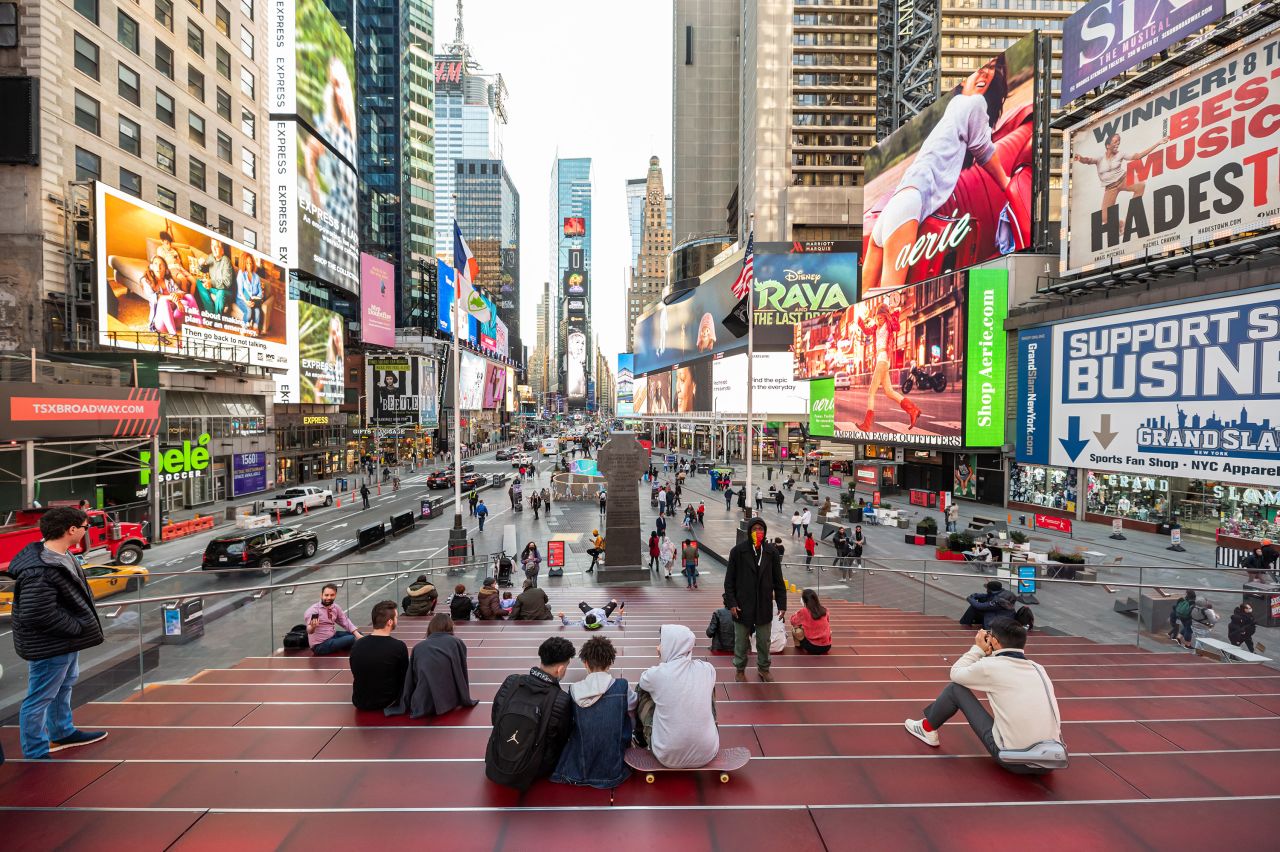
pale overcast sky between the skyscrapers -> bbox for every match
[435,0,672,360]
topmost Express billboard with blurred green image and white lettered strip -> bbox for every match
[268,0,356,164]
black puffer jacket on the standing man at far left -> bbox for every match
[9,541,102,660]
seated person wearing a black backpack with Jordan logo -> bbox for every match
[484,636,573,792]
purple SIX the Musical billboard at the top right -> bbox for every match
[1061,0,1226,106]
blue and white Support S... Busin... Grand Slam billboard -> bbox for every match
[1014,288,1280,487]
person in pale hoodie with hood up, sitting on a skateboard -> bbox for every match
[636,624,719,769]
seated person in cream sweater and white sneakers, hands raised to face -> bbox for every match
[905,618,1065,774]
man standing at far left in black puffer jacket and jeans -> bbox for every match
[9,508,106,760]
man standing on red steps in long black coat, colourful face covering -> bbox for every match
[724,518,787,683]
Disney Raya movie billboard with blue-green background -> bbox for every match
[751,241,858,349]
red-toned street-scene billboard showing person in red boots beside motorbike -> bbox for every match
[794,274,965,446]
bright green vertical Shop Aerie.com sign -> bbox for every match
[964,269,1009,446]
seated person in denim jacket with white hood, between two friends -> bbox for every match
[552,636,636,789]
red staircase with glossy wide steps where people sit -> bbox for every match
[0,588,1280,852]
